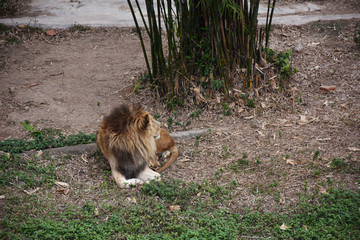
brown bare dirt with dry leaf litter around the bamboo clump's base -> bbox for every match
[0,2,360,211]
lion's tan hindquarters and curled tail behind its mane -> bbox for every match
[153,128,179,173]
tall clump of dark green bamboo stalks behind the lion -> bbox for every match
[128,0,276,101]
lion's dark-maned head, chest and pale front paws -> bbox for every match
[96,104,160,188]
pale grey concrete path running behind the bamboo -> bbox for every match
[0,0,360,28]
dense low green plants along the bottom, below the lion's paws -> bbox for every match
[0,177,360,239]
